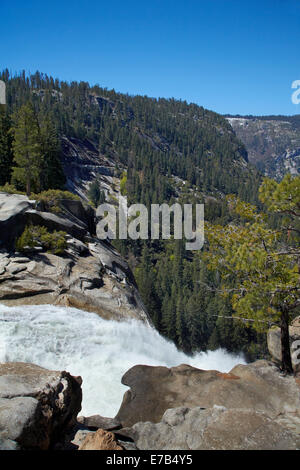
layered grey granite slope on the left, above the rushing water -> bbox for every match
[0,193,149,322]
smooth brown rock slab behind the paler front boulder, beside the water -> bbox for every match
[116,361,300,430]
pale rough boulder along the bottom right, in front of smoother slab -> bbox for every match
[119,406,300,450]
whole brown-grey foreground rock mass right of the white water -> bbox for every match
[116,361,300,450]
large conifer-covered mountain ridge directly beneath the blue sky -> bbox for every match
[0,70,259,204]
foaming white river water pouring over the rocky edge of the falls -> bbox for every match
[0,305,245,417]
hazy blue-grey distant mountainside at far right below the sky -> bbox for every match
[227,115,300,179]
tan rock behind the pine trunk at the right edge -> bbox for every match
[267,317,300,372]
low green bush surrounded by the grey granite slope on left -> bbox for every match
[16,225,67,255]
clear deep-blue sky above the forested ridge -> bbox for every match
[0,0,300,115]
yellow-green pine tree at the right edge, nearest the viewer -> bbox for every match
[206,175,300,372]
